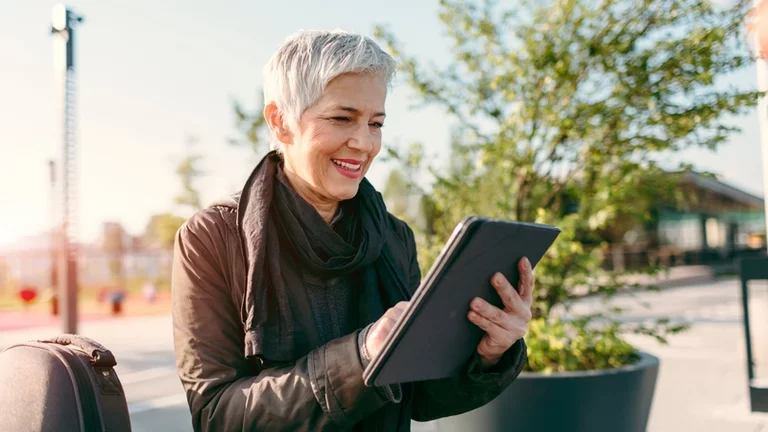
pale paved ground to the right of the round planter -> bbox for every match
[577,279,768,432]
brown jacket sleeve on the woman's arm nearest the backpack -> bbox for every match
[172,214,387,431]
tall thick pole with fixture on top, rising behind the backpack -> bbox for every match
[51,4,83,334]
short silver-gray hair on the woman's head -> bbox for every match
[264,29,397,150]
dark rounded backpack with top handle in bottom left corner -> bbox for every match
[0,334,131,432]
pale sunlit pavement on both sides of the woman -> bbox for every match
[0,280,768,432]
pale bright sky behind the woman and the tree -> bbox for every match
[0,0,763,246]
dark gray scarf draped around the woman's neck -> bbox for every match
[237,152,409,362]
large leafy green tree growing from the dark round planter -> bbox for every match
[376,0,758,370]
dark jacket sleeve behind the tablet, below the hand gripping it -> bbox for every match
[406,223,528,421]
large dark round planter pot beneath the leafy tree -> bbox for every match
[437,352,659,432]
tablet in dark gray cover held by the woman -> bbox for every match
[363,217,560,386]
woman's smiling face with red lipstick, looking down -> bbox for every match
[283,74,387,202]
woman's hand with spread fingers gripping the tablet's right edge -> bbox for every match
[467,258,533,368]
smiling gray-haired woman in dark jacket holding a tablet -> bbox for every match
[173,31,533,431]
